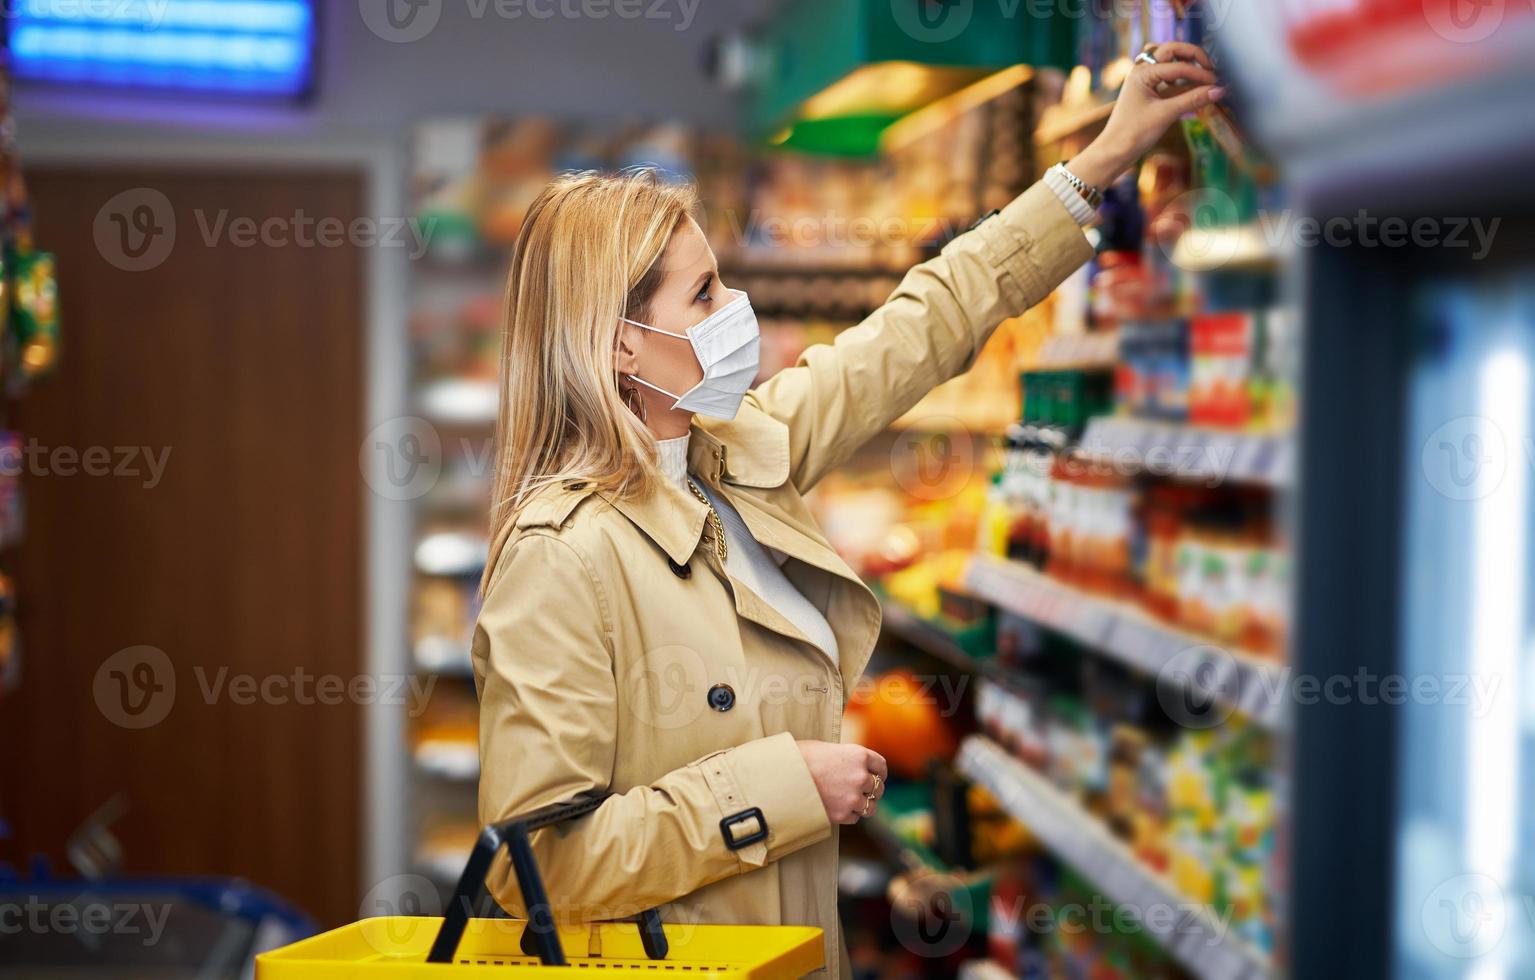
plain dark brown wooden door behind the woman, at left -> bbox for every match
[0,167,373,925]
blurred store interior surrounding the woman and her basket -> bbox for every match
[0,0,1535,980]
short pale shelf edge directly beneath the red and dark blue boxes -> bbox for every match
[1081,416,1294,487]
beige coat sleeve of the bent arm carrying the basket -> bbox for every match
[474,533,830,920]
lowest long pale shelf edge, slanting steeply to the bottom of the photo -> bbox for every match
[958,736,1271,980]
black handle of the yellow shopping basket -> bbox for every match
[427,793,666,966]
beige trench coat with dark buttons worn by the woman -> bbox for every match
[473,184,1091,977]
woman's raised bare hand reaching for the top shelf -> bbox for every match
[1065,41,1226,187]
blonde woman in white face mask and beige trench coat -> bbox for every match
[473,43,1222,977]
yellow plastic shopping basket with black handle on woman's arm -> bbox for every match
[256,796,824,980]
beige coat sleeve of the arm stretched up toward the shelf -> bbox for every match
[749,183,1093,492]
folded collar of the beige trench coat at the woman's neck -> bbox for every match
[603,402,789,565]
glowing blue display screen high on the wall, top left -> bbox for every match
[8,0,315,97]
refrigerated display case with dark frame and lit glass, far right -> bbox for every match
[1226,0,1535,978]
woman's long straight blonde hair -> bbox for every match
[480,169,697,588]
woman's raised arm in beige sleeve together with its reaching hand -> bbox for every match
[751,41,1225,490]
